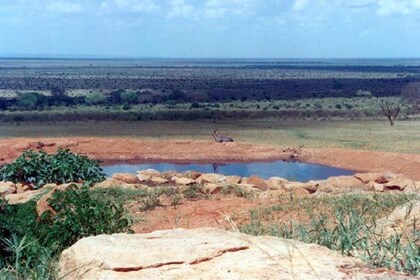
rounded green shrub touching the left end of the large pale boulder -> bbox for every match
[41,185,130,248]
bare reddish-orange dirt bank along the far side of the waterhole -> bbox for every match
[0,137,420,180]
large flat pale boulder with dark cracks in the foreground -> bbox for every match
[58,228,408,280]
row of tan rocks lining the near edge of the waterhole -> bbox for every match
[0,169,420,204]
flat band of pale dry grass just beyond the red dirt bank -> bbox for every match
[0,119,420,154]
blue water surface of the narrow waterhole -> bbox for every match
[103,161,354,182]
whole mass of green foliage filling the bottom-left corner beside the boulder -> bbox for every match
[0,185,131,279]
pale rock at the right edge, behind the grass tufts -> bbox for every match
[375,200,420,238]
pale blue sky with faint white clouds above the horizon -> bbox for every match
[0,0,420,58]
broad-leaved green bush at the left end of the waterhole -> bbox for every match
[0,149,105,188]
